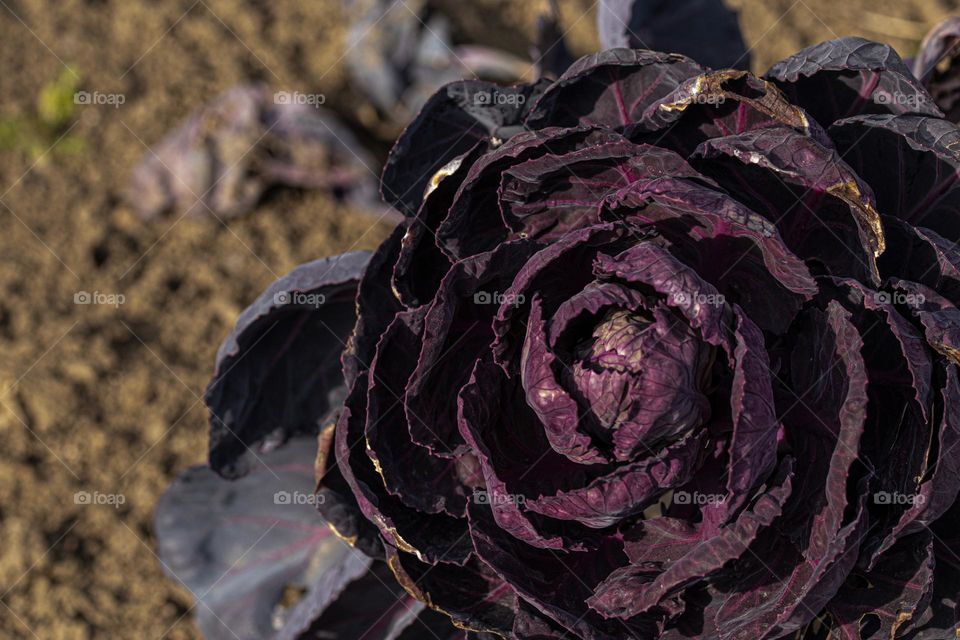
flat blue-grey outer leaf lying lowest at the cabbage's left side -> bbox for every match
[155,437,371,640]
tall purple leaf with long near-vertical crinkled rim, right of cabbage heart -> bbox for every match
[717,301,869,640]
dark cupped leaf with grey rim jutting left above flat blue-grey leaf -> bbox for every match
[204,251,370,478]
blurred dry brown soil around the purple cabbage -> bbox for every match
[0,0,958,640]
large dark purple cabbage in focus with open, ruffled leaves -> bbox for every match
[159,12,960,640]
